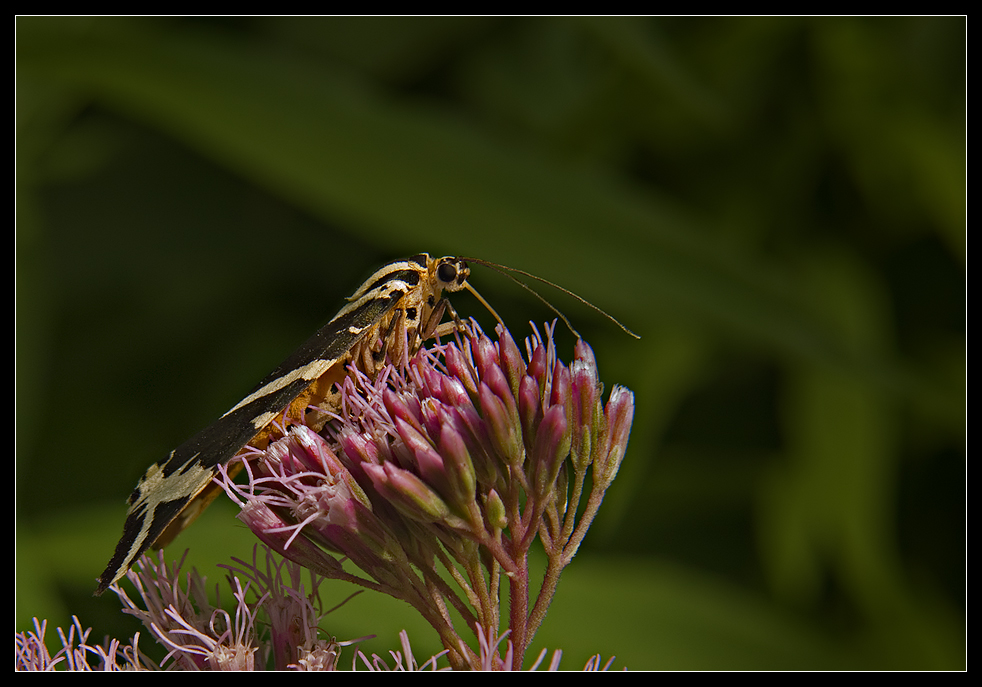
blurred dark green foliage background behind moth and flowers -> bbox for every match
[15,17,966,669]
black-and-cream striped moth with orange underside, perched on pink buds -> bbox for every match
[96,253,470,595]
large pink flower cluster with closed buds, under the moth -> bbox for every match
[224,325,634,668]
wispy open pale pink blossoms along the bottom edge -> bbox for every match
[14,547,624,671]
